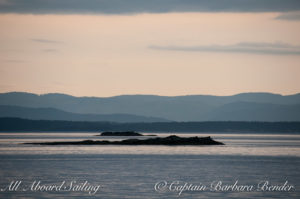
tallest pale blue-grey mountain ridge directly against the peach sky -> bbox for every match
[0,92,300,121]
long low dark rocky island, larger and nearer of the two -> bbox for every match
[24,135,224,146]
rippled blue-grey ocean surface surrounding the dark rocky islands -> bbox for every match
[0,132,300,199]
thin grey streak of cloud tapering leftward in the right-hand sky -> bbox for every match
[148,42,300,55]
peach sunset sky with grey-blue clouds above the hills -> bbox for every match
[0,0,300,97]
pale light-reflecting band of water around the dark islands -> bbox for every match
[0,133,300,157]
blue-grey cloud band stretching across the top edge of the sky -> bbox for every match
[0,0,300,14]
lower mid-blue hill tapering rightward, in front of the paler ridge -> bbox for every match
[0,105,169,123]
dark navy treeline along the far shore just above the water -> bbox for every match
[0,118,300,133]
